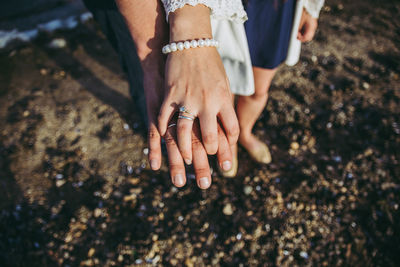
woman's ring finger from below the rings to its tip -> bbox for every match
[177,115,193,165]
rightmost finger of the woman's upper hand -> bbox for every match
[218,106,240,145]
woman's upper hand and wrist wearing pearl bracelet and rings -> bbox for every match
[158,5,239,164]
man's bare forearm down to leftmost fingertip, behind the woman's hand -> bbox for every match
[116,0,168,170]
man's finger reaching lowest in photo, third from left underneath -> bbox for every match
[192,122,211,189]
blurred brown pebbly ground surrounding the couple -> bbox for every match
[0,0,400,266]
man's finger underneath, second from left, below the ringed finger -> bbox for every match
[164,126,186,187]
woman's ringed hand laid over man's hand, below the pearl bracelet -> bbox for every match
[146,47,239,189]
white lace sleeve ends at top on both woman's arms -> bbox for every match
[161,0,324,22]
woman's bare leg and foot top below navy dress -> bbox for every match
[236,67,276,163]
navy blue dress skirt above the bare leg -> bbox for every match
[245,0,296,69]
